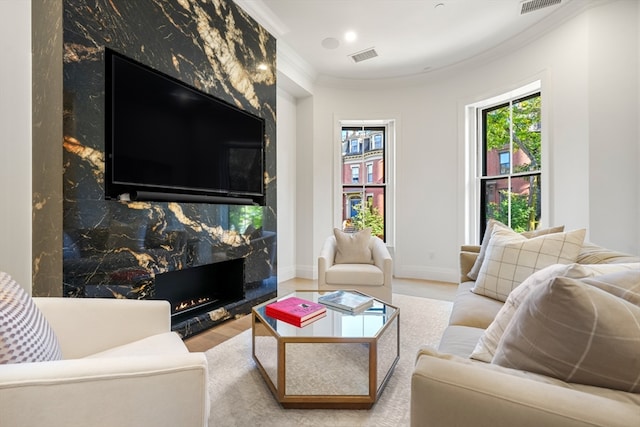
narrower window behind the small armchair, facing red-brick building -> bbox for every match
[341,126,387,239]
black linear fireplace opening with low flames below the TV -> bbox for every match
[155,258,245,325]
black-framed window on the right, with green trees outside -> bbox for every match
[477,92,542,236]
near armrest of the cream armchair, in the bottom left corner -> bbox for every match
[0,353,209,427]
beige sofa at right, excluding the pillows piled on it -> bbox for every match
[411,234,640,427]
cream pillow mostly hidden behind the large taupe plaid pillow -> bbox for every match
[470,263,640,363]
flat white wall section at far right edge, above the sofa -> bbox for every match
[588,1,640,252]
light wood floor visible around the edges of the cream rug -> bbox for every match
[185,278,457,351]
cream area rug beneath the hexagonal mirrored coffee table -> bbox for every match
[206,294,451,427]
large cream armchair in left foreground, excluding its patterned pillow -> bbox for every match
[0,298,209,427]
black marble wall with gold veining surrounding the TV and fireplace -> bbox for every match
[62,0,276,336]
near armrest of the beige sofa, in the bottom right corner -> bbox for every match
[411,354,640,427]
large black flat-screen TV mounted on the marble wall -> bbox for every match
[105,49,265,204]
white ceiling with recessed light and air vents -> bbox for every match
[235,0,602,80]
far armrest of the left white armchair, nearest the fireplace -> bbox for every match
[33,297,171,359]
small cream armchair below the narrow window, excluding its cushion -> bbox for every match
[318,236,393,303]
